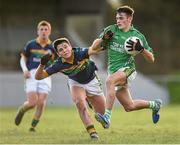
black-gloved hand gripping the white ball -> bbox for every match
[126,39,144,53]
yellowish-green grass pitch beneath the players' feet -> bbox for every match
[0,105,180,144]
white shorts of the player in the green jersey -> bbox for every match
[115,67,137,91]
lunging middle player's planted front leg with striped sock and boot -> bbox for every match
[71,86,98,139]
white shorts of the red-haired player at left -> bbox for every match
[25,69,51,94]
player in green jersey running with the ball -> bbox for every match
[95,6,161,128]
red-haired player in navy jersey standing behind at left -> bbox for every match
[15,21,54,131]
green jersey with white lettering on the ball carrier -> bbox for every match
[99,24,153,74]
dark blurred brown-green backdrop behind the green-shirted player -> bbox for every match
[106,0,180,74]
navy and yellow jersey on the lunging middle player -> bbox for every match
[46,48,97,84]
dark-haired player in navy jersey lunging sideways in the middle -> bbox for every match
[35,38,105,139]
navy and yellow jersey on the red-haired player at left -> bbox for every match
[22,38,54,70]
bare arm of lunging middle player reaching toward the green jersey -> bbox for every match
[88,39,103,55]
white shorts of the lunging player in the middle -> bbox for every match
[68,76,104,97]
